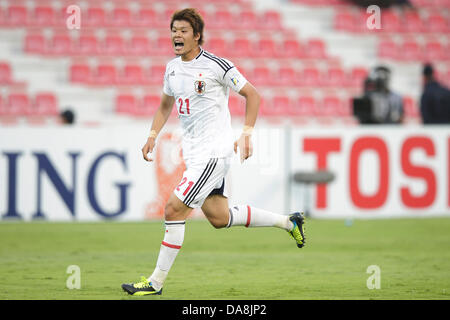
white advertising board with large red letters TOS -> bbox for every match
[290,126,450,217]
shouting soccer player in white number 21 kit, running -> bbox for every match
[122,8,305,296]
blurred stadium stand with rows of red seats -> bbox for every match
[0,0,450,121]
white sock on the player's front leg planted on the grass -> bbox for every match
[148,221,185,290]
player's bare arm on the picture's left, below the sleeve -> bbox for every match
[142,93,175,161]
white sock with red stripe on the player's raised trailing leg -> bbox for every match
[227,205,294,231]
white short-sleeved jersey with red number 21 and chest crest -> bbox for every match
[163,48,247,162]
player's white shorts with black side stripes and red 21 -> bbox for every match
[174,158,231,208]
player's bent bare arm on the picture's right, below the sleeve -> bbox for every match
[234,82,261,163]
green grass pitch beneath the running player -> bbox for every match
[0,218,450,300]
